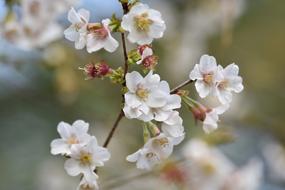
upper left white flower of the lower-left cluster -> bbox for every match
[51,120,91,155]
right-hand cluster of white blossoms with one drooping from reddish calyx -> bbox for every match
[189,55,244,133]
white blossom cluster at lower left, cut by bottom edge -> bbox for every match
[51,120,110,190]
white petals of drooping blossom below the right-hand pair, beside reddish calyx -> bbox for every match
[203,104,229,133]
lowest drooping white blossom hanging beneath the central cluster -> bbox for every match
[127,133,177,170]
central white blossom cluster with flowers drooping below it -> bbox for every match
[123,71,184,169]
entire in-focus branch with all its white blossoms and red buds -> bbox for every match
[48,0,243,190]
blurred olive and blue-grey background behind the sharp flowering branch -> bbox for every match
[0,0,285,190]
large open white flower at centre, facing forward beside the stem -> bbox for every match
[123,71,167,121]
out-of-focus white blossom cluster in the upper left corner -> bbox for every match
[0,0,77,50]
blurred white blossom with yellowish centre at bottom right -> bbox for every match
[184,139,235,190]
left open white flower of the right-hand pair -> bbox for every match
[189,55,220,98]
